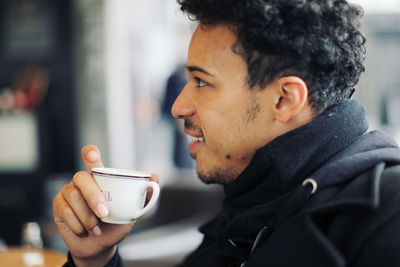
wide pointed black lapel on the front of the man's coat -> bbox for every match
[248,163,385,267]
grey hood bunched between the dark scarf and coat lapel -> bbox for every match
[310,131,400,213]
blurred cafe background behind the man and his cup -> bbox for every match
[0,0,400,266]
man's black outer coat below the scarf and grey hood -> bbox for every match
[180,147,400,267]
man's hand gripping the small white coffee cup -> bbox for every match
[53,145,158,267]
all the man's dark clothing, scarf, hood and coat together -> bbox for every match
[65,100,400,267]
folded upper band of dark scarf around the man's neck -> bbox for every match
[223,100,368,217]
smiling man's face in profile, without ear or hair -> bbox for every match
[172,25,282,184]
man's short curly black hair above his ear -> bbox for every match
[177,0,365,114]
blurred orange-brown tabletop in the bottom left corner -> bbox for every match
[0,247,67,267]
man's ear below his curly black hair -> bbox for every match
[274,76,308,123]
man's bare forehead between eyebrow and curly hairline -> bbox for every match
[188,24,247,73]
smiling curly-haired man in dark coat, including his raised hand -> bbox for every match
[54,0,400,267]
